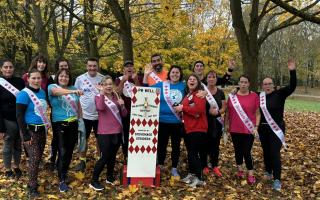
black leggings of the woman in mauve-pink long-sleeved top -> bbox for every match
[92,133,122,181]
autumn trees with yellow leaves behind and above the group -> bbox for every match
[0,0,320,88]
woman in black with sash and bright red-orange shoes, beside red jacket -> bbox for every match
[201,71,227,177]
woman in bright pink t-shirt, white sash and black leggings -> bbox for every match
[225,75,260,184]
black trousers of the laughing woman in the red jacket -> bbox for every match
[185,132,206,180]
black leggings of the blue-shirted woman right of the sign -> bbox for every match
[157,122,182,168]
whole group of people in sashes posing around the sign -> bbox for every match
[0,54,296,196]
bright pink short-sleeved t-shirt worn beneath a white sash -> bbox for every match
[227,92,259,134]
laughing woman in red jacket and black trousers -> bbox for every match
[175,74,208,187]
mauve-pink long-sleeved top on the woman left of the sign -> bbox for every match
[95,95,127,134]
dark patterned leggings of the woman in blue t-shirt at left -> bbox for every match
[25,130,46,188]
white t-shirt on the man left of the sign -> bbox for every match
[74,72,104,120]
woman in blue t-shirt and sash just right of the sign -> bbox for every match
[152,65,185,177]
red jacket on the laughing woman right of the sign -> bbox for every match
[182,91,208,133]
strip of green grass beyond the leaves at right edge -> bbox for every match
[285,99,320,112]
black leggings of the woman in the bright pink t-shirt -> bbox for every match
[231,133,254,170]
